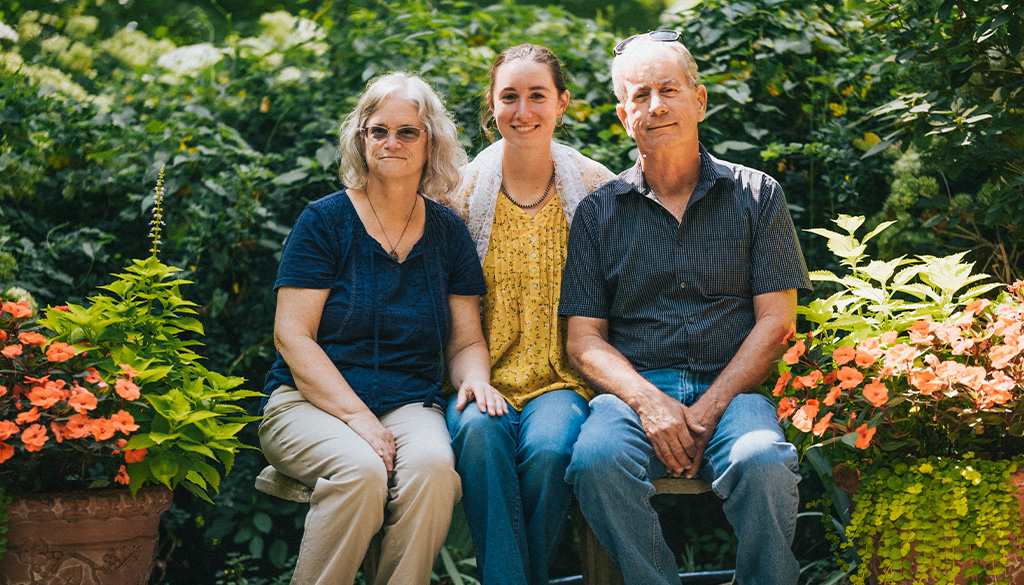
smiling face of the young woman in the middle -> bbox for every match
[490,58,569,148]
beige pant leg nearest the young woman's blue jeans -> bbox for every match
[376,403,462,585]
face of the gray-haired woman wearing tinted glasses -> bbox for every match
[364,97,428,181]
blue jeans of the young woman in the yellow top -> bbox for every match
[447,390,589,585]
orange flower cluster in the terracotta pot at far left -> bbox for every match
[0,301,146,485]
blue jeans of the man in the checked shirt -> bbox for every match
[565,369,800,585]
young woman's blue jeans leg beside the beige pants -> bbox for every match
[447,401,529,585]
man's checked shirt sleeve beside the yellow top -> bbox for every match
[558,201,611,319]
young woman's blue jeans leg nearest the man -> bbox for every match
[517,390,590,585]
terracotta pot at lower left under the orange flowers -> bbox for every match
[0,488,174,585]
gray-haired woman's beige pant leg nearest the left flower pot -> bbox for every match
[259,386,387,585]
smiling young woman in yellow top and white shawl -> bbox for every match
[447,44,612,585]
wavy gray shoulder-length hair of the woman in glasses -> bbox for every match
[338,72,468,201]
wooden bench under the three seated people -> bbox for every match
[256,465,711,585]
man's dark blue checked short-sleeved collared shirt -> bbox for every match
[558,145,811,373]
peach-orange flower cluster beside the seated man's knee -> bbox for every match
[772,290,1024,449]
